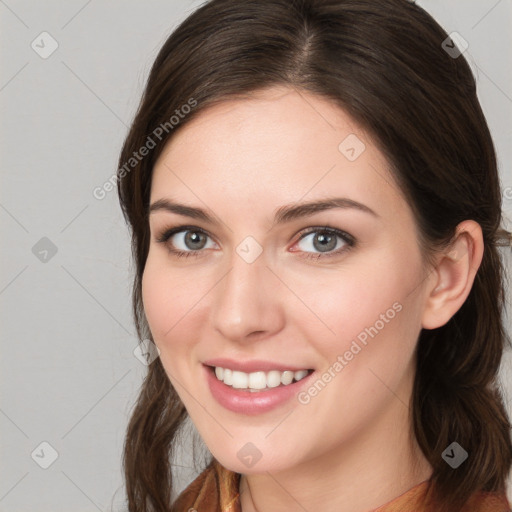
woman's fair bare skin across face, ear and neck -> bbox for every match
[142,87,483,512]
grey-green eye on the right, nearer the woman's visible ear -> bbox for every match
[296,226,355,259]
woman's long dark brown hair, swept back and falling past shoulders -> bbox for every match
[117,0,512,512]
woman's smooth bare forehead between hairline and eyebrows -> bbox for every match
[151,87,407,222]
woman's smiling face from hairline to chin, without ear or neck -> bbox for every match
[142,88,429,473]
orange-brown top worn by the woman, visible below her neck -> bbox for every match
[172,458,511,512]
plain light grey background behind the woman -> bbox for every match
[0,0,512,512]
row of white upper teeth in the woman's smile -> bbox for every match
[215,366,309,392]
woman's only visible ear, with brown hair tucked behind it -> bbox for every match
[422,220,484,329]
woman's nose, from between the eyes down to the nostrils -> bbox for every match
[212,248,285,343]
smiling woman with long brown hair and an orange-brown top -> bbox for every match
[118,0,512,512]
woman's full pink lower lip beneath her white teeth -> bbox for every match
[203,365,315,416]
